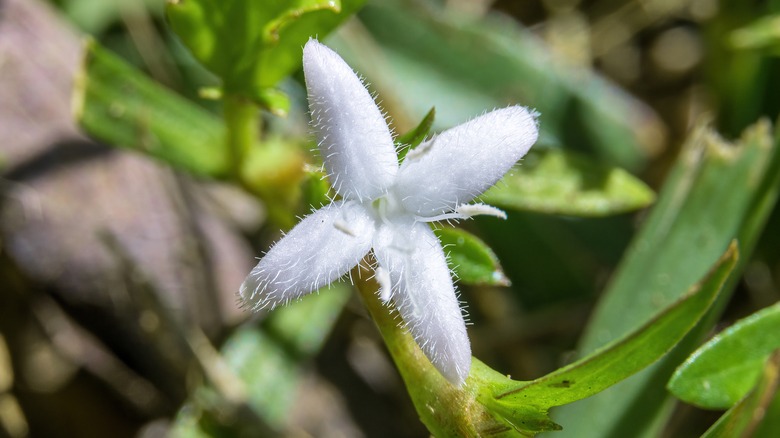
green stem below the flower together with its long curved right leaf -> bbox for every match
[353,244,737,437]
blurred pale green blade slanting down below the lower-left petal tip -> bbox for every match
[172,285,351,437]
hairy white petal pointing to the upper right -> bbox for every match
[396,106,539,216]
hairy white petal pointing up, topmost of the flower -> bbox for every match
[303,40,398,199]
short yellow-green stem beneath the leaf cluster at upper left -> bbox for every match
[223,95,260,181]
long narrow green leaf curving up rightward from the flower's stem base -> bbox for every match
[482,243,738,432]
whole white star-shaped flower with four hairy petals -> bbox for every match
[240,40,538,386]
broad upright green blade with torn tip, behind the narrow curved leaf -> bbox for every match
[555,121,780,438]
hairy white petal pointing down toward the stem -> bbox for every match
[374,221,471,386]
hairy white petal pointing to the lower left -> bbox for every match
[239,201,374,310]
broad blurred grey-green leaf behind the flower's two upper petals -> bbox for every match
[331,2,656,173]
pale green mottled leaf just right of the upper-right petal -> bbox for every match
[481,149,655,216]
